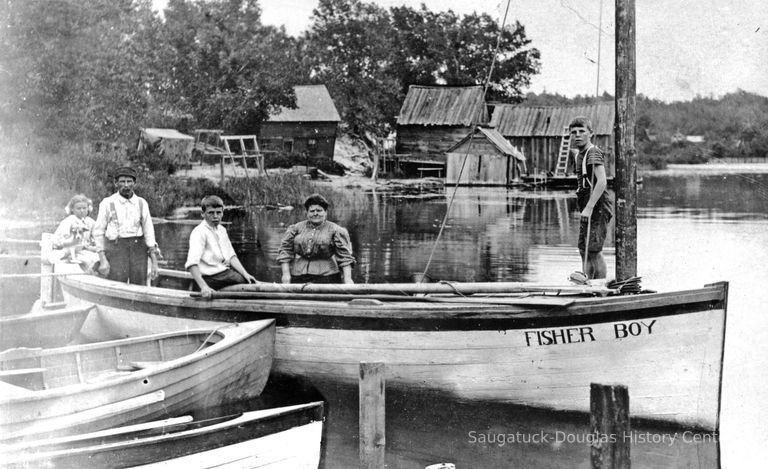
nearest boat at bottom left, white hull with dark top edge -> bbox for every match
[0,402,323,469]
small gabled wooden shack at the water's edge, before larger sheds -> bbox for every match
[445,127,525,186]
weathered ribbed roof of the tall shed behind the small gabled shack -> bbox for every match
[397,85,488,126]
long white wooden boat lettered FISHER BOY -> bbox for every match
[61,264,728,429]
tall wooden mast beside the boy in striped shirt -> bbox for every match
[614,0,637,280]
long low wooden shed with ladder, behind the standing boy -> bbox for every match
[491,102,615,177]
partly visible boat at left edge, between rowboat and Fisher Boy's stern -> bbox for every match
[0,306,92,350]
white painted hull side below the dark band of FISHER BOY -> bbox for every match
[274,310,724,428]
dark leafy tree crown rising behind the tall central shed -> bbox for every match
[303,0,540,135]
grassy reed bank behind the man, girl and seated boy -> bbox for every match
[0,138,343,219]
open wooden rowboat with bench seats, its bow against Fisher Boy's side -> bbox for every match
[0,320,275,440]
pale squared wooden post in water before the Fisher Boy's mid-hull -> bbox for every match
[359,362,386,469]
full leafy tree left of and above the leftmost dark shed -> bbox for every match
[163,0,307,133]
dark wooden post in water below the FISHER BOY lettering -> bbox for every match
[589,383,631,469]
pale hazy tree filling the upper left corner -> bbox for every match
[0,0,166,140]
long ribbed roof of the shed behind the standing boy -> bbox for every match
[491,101,616,137]
